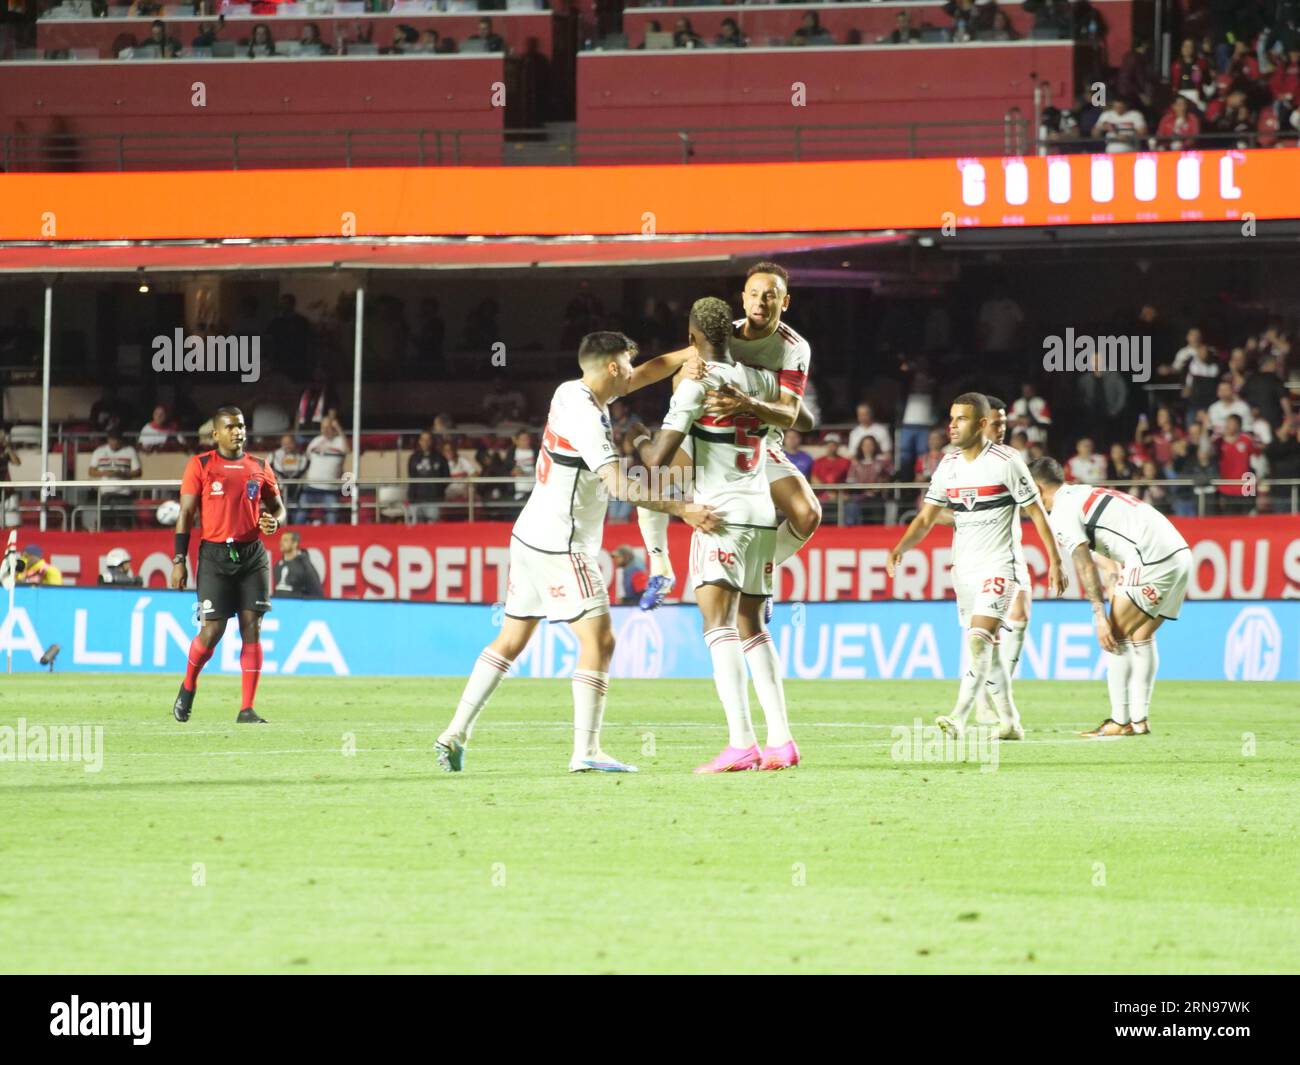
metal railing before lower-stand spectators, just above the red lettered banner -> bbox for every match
[0,475,1300,532]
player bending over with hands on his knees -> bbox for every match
[1030,458,1192,737]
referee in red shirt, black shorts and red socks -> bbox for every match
[172,407,286,724]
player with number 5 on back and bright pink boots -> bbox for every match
[628,296,800,772]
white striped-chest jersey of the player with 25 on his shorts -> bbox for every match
[926,442,1039,576]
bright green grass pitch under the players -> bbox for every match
[0,675,1300,973]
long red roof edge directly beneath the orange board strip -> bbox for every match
[0,234,905,274]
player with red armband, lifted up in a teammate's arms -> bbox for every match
[638,263,822,610]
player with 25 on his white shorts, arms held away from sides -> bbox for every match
[885,391,1066,740]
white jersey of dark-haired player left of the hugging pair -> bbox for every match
[514,381,618,555]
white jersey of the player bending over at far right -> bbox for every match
[1048,485,1187,567]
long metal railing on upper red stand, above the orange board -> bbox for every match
[0,112,1034,172]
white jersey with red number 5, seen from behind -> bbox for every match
[663,363,779,528]
